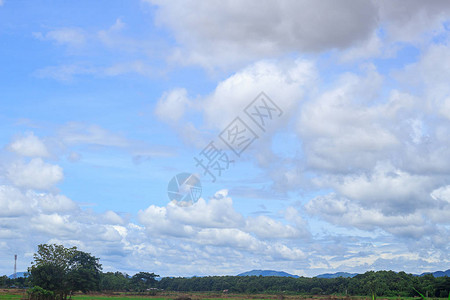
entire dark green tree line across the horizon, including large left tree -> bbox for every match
[0,244,450,300]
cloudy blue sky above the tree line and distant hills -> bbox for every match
[0,0,450,276]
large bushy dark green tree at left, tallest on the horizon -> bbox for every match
[28,244,101,299]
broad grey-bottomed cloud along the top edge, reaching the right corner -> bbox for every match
[146,0,450,67]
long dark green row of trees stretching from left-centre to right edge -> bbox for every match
[158,271,450,297]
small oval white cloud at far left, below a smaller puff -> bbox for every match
[6,158,64,189]
